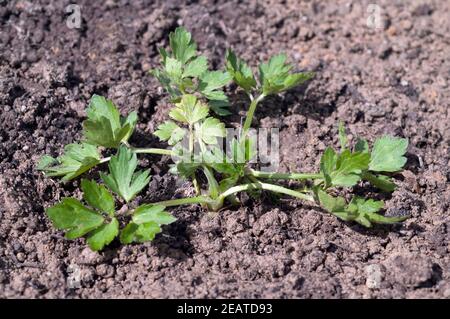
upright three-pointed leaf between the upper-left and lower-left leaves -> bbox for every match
[100,146,150,202]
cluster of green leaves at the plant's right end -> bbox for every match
[314,124,408,227]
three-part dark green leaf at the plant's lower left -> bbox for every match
[47,179,176,251]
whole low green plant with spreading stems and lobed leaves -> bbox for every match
[38,27,408,250]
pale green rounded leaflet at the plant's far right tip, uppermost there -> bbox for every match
[369,135,408,172]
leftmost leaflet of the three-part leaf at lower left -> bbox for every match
[46,198,104,239]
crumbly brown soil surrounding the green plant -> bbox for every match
[0,0,450,298]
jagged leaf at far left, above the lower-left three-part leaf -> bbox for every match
[37,143,100,181]
